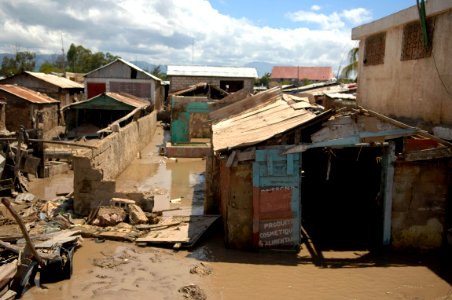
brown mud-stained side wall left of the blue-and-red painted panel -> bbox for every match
[220,159,253,249]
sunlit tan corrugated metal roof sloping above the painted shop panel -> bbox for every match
[212,91,316,151]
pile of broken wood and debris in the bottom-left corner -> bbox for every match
[0,194,81,299]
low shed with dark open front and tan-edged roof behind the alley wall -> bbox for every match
[62,92,150,138]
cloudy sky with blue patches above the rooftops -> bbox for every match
[0,0,416,69]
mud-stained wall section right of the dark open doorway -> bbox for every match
[391,160,450,250]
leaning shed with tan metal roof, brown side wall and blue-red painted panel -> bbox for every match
[205,88,322,248]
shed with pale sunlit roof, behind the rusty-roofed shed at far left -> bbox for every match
[0,71,83,106]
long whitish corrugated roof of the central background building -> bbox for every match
[166,66,258,78]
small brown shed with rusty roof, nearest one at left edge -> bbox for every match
[0,84,60,133]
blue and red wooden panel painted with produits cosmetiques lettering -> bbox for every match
[253,148,301,248]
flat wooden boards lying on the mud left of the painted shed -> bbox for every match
[136,215,220,247]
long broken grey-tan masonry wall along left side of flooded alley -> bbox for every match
[73,111,157,215]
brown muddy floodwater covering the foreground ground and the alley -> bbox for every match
[23,123,452,300]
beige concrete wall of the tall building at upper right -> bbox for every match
[354,7,452,129]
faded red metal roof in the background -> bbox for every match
[271,66,334,80]
